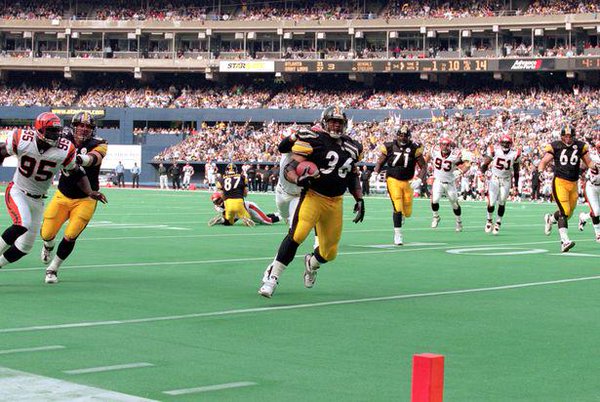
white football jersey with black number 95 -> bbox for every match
[6,129,77,195]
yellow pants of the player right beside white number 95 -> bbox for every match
[41,190,97,241]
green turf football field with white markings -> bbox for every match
[0,189,600,401]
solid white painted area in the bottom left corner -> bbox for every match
[0,367,152,402]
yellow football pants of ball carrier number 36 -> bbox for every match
[290,190,343,261]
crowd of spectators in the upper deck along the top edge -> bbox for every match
[0,0,600,21]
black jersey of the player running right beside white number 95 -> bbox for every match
[58,132,108,198]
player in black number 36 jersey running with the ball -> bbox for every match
[258,106,365,297]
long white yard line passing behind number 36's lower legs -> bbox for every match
[3,239,584,273]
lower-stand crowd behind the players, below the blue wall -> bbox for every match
[155,108,600,199]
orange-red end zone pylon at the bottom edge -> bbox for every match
[411,353,444,402]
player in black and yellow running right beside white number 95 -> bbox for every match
[41,112,108,283]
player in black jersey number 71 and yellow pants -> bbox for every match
[373,126,427,246]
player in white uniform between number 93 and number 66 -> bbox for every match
[481,135,521,235]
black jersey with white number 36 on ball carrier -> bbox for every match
[292,127,362,197]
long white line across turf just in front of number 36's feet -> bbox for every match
[0,275,600,334]
